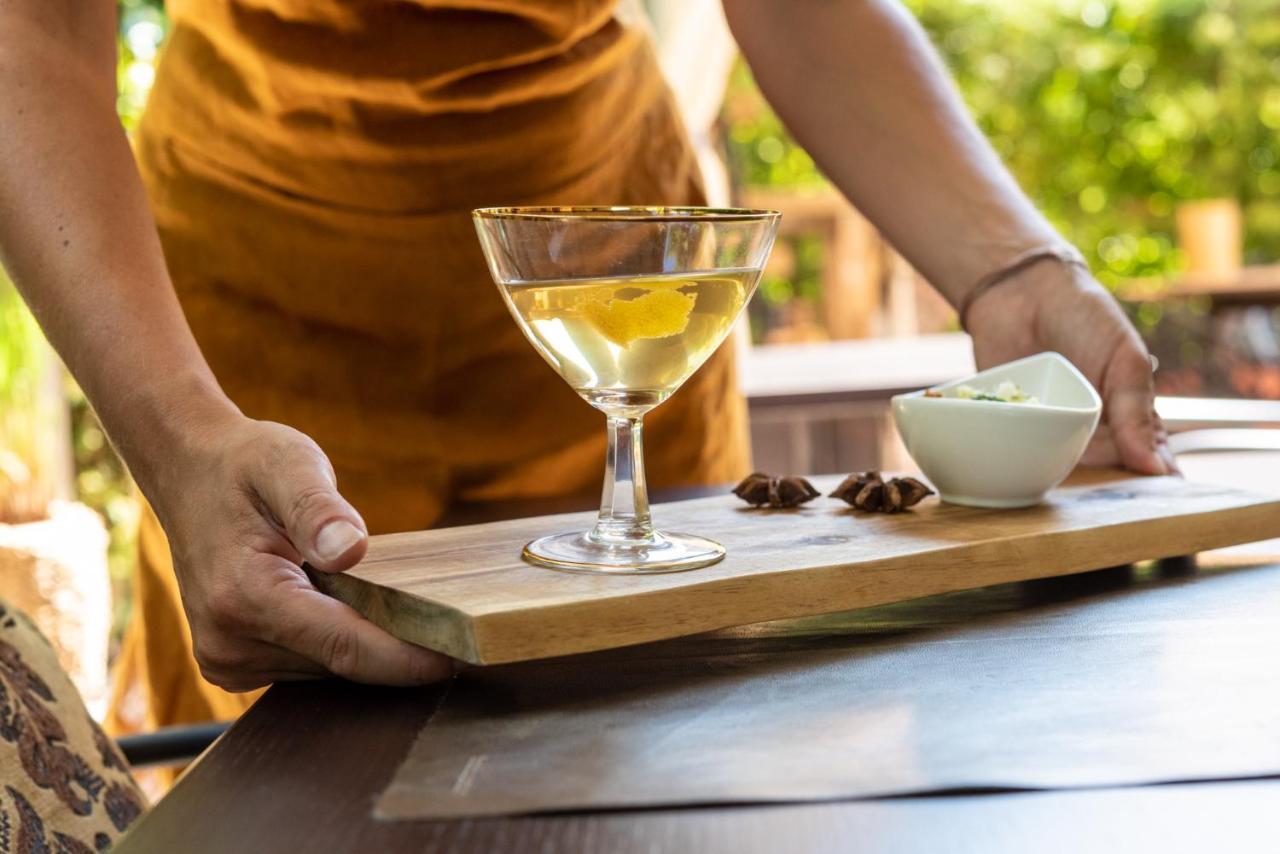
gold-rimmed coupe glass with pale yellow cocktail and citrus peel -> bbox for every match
[474,207,780,574]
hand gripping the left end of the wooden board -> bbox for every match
[146,414,453,691]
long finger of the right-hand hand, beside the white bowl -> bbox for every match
[1103,342,1170,475]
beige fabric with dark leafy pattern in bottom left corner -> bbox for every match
[0,600,146,854]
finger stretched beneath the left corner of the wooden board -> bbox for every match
[269,573,454,685]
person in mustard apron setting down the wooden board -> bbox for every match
[0,0,1172,727]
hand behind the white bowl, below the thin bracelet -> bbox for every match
[969,260,1178,475]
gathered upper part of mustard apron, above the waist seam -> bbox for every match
[141,0,662,213]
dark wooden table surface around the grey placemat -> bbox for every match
[115,455,1280,854]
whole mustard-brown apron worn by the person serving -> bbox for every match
[109,0,749,734]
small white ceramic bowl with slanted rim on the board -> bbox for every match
[893,353,1102,507]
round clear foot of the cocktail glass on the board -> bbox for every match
[524,533,724,575]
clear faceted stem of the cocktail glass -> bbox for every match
[589,415,653,545]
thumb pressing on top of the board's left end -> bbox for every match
[253,437,369,572]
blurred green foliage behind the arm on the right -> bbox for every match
[726,0,1280,284]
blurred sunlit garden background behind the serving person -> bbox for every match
[0,0,1280,706]
